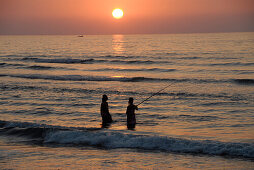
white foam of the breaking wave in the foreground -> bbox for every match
[45,131,254,158]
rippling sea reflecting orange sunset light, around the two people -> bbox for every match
[0,32,254,170]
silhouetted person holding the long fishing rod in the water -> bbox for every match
[126,97,138,129]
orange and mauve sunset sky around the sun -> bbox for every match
[0,0,254,35]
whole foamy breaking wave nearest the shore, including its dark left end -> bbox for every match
[0,121,254,158]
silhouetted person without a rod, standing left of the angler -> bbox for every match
[101,94,112,126]
